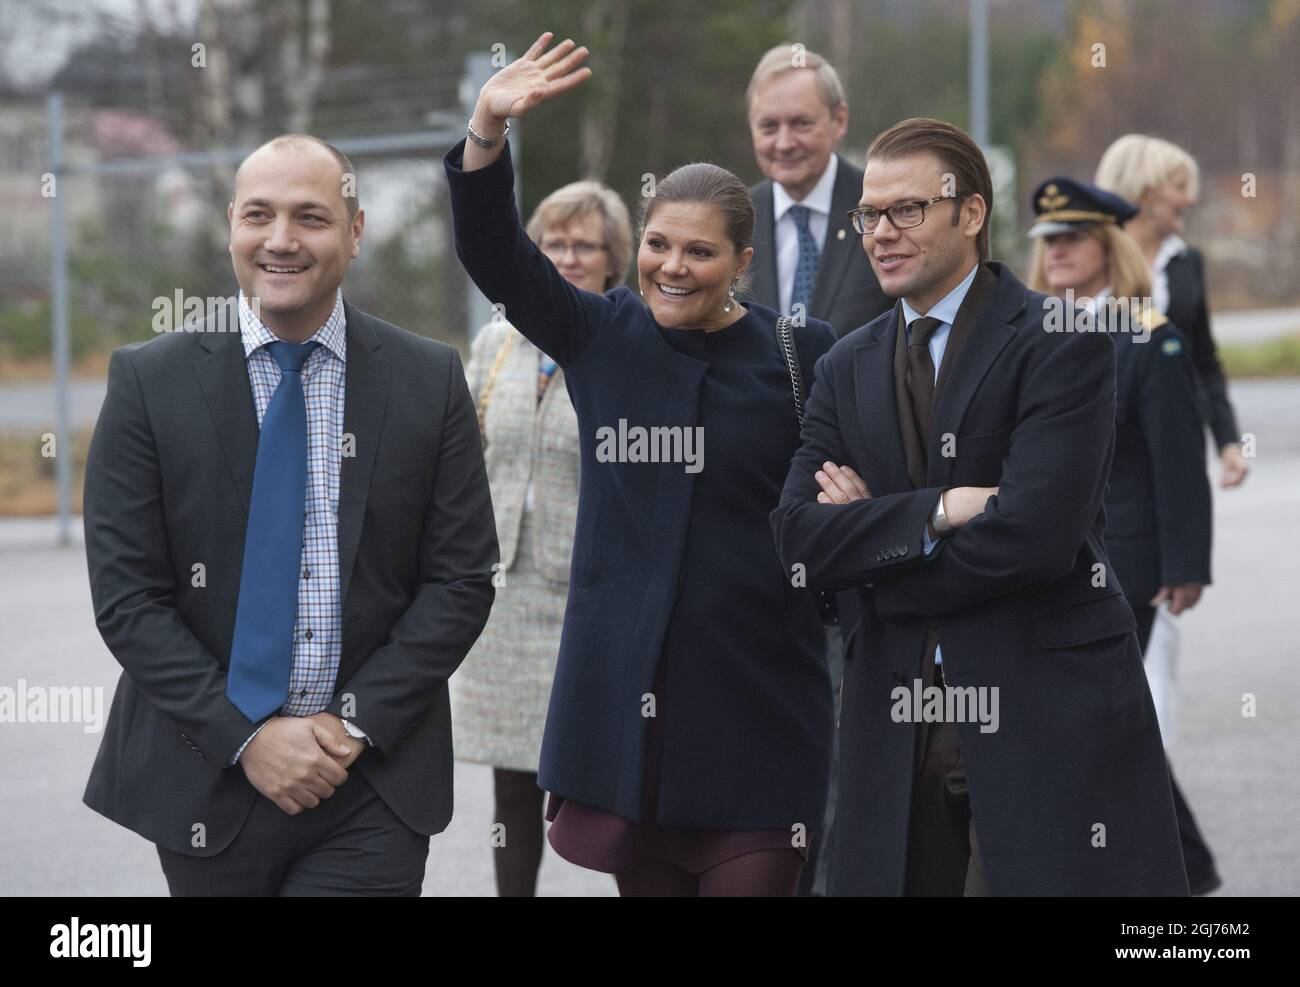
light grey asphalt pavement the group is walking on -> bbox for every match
[0,380,1300,896]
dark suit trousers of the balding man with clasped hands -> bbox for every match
[157,752,429,897]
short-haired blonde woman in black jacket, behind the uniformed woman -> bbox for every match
[1096,134,1251,488]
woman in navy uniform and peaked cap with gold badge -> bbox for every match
[1030,177,1219,895]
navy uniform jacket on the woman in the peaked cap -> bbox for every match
[1106,315,1212,607]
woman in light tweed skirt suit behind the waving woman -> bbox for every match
[451,182,632,896]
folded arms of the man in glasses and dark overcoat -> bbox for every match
[772,333,1115,619]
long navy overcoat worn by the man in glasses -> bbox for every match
[772,264,1187,895]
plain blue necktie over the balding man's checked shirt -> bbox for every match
[226,342,320,723]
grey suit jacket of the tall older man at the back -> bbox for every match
[749,155,894,337]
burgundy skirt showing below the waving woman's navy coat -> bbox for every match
[546,657,809,874]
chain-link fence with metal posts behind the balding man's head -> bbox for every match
[10,119,488,360]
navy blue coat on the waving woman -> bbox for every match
[445,143,835,830]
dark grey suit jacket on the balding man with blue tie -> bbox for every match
[85,295,497,857]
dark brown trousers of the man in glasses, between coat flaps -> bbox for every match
[904,641,988,897]
